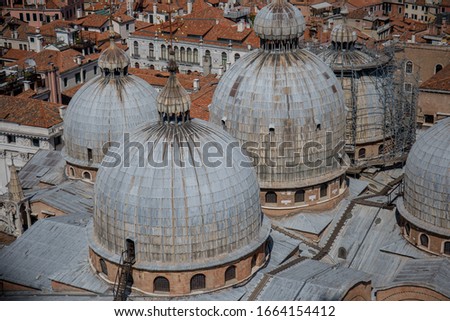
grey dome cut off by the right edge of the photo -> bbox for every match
[402,117,450,230]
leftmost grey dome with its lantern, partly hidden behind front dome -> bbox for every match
[64,40,158,168]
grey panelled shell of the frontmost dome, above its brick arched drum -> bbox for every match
[91,120,269,270]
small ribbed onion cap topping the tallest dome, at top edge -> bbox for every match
[253,0,306,40]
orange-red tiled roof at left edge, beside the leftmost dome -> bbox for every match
[0,96,63,128]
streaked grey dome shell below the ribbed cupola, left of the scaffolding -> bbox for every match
[210,50,346,188]
